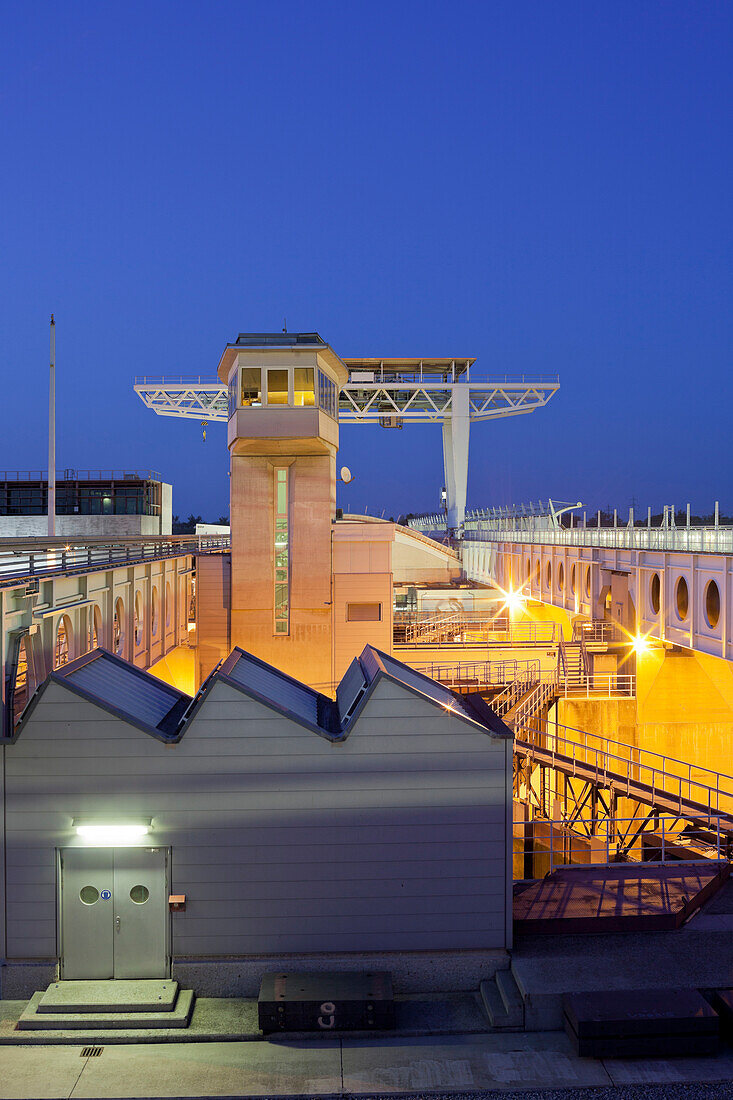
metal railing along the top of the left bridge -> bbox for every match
[0,535,230,587]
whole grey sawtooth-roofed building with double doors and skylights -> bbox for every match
[0,647,512,997]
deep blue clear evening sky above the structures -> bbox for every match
[0,0,733,518]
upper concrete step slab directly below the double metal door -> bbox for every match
[37,979,178,1012]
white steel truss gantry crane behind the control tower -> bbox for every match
[134,359,560,531]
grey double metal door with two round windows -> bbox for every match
[59,848,169,980]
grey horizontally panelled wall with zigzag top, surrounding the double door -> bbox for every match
[3,681,512,960]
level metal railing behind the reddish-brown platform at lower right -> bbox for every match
[513,815,729,878]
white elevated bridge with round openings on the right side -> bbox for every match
[411,502,733,660]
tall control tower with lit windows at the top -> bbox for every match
[218,332,349,690]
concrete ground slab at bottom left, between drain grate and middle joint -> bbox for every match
[74,1038,341,1100]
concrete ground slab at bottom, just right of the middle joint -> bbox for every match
[342,1034,611,1093]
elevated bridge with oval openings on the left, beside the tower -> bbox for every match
[0,535,229,734]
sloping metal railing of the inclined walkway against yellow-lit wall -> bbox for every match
[513,721,733,832]
